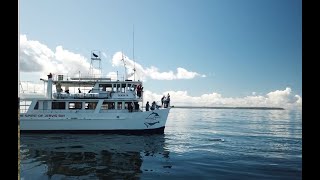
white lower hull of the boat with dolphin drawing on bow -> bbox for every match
[20,108,170,133]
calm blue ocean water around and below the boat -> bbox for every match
[20,108,302,180]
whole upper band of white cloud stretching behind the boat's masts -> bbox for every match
[20,35,206,80]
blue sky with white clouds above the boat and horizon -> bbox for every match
[19,0,302,108]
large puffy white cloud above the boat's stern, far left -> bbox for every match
[20,35,99,78]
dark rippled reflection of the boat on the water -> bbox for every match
[20,134,171,179]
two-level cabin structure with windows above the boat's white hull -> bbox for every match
[20,76,143,113]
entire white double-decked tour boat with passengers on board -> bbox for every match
[20,58,170,134]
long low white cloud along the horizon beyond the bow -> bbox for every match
[144,87,302,109]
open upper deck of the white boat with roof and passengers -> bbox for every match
[40,75,143,101]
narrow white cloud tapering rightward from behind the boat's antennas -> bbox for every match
[112,52,206,80]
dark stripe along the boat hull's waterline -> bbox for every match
[20,126,165,134]
